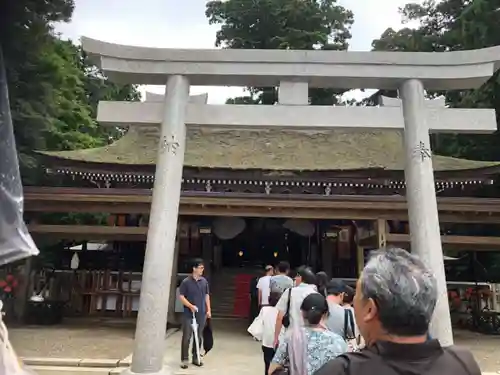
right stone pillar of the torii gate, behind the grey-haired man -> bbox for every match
[399,79,453,346]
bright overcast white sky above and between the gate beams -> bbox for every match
[56,0,420,104]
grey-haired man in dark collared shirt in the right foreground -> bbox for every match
[315,248,481,375]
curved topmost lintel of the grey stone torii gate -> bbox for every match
[82,37,500,90]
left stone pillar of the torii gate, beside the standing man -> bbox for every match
[131,76,189,374]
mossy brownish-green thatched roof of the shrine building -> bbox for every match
[43,127,499,171]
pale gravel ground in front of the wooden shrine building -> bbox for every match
[9,322,500,372]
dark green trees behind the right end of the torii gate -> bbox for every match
[372,0,500,160]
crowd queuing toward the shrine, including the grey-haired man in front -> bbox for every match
[249,249,481,375]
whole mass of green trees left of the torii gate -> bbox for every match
[0,0,139,184]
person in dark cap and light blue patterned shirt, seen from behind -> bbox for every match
[268,293,347,375]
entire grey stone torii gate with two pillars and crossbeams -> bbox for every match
[82,38,500,374]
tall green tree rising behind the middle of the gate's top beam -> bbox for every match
[206,0,353,105]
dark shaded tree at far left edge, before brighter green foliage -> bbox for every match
[0,0,74,177]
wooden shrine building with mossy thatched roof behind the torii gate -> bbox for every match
[21,95,500,317]
